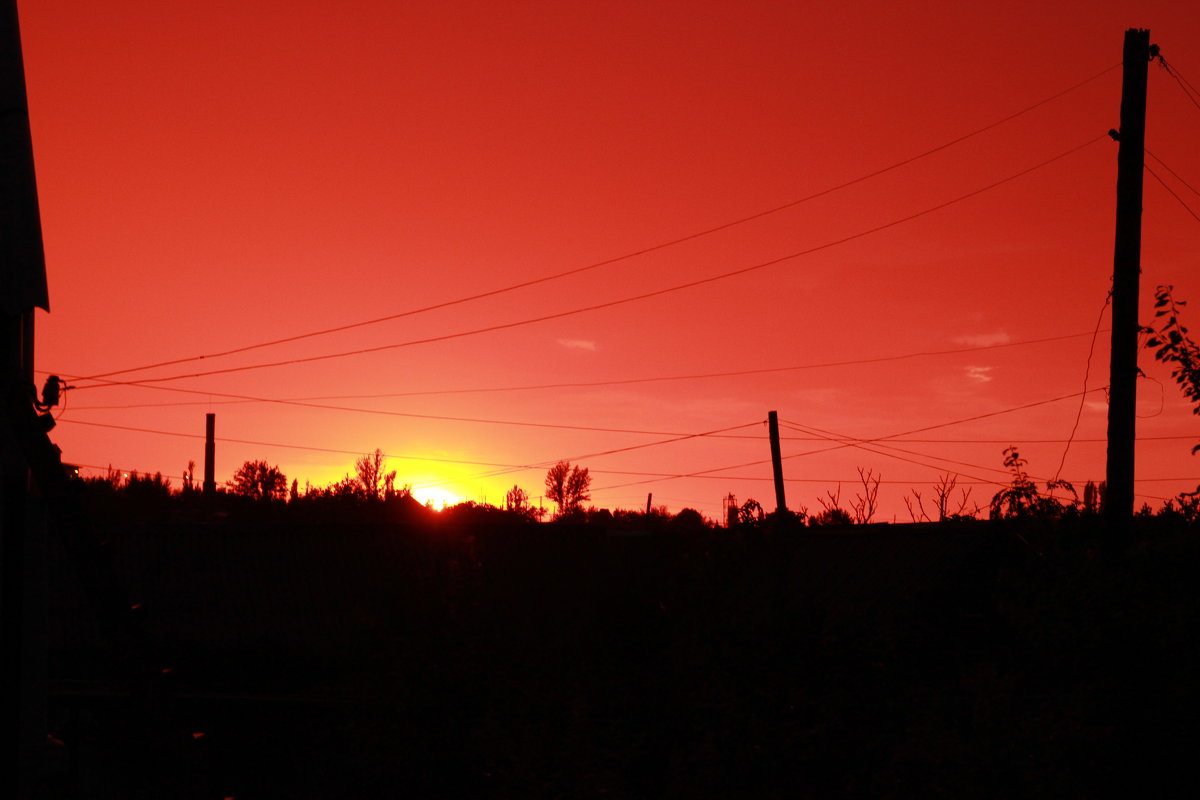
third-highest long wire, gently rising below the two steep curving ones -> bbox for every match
[56,331,1091,411]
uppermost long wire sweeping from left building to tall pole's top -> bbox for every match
[77,64,1121,380]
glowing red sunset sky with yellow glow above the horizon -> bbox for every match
[20,0,1200,521]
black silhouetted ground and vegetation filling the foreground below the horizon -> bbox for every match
[41,491,1200,800]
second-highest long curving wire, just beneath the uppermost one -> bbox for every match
[76,134,1108,391]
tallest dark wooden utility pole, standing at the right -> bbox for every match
[1104,28,1151,534]
